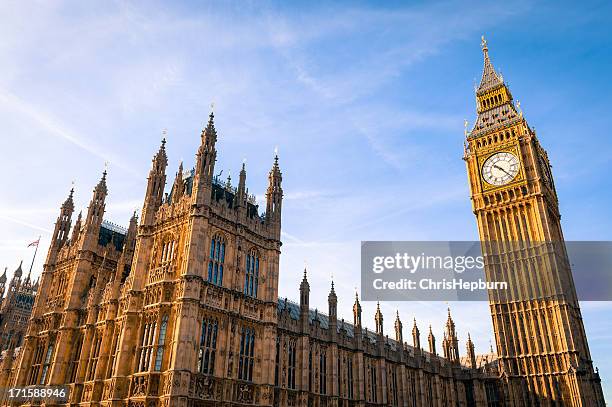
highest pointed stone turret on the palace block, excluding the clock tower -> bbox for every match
[193,112,217,205]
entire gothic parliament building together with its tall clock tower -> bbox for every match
[0,40,605,407]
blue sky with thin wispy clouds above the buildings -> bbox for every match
[0,1,612,397]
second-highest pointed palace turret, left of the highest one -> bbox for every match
[141,138,168,226]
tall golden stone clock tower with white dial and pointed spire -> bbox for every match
[464,37,605,407]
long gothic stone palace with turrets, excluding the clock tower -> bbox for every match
[0,39,598,407]
